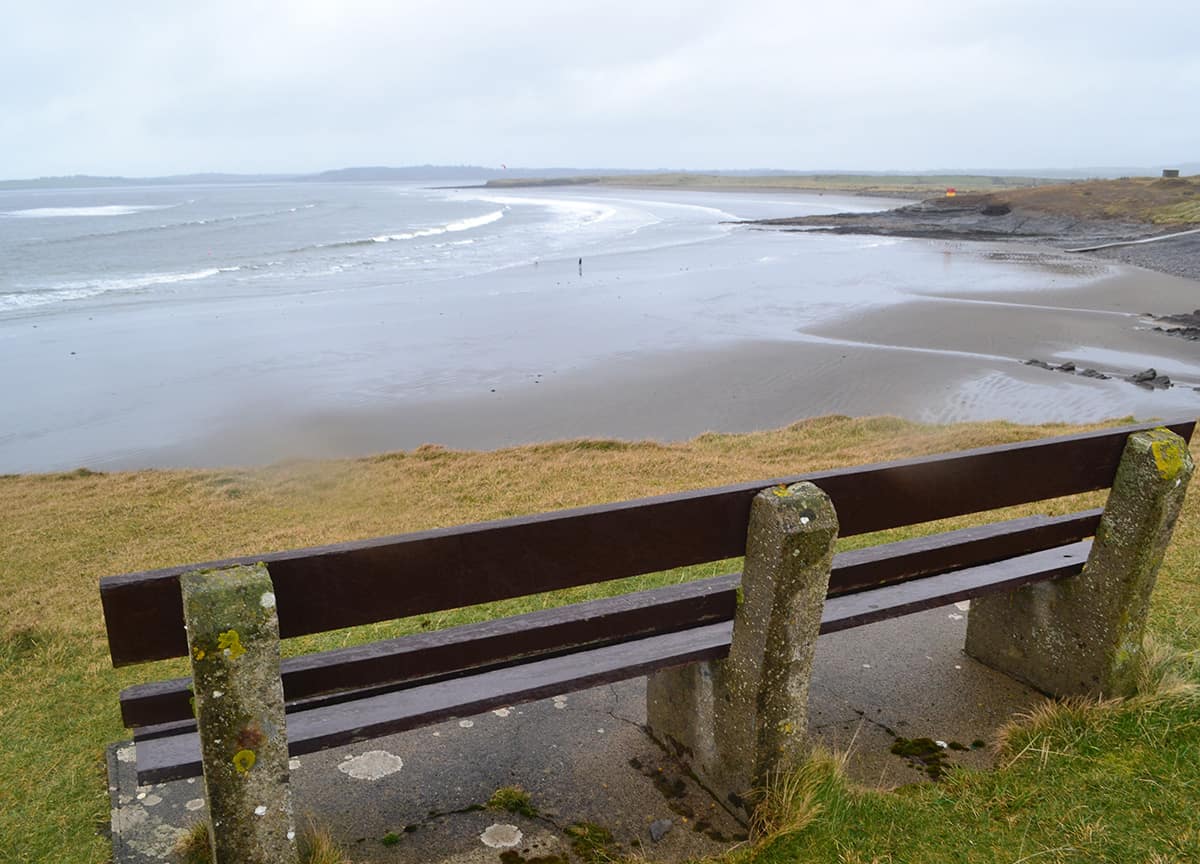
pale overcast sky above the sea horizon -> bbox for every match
[0,0,1200,178]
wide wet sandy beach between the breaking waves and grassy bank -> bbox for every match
[0,190,1200,472]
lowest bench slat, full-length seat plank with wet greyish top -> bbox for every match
[137,540,1091,784]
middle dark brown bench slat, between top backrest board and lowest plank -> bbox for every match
[121,509,1100,736]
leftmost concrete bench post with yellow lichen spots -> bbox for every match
[179,564,296,864]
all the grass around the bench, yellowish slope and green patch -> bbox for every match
[0,418,1200,863]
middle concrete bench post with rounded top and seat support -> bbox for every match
[647,482,838,818]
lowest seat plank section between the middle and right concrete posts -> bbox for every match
[821,540,1092,634]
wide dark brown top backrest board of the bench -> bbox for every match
[101,420,1195,666]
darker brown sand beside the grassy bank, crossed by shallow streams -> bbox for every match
[137,256,1200,464]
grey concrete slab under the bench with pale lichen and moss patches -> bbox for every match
[109,604,1040,864]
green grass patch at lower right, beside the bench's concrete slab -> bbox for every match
[731,643,1200,864]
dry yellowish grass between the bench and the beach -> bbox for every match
[0,418,1200,864]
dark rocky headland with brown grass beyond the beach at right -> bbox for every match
[739,194,1200,282]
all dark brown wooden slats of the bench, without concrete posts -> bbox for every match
[101,420,1194,849]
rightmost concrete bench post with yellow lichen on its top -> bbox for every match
[966,428,1194,697]
